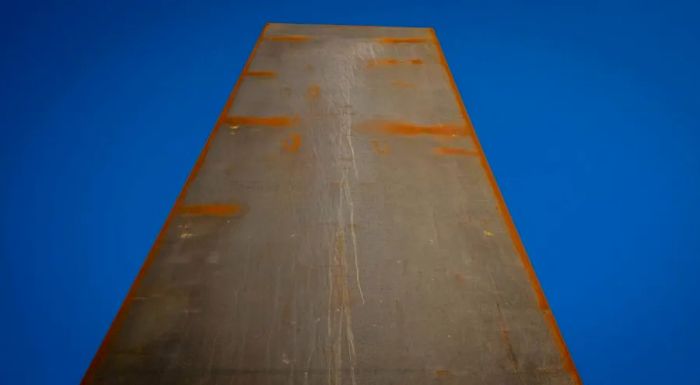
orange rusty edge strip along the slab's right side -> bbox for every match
[430,28,583,385]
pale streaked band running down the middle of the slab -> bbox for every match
[322,38,376,385]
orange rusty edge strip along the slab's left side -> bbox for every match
[80,23,270,385]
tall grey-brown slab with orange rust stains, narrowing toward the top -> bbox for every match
[83,24,578,385]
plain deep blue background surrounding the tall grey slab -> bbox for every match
[0,0,700,384]
